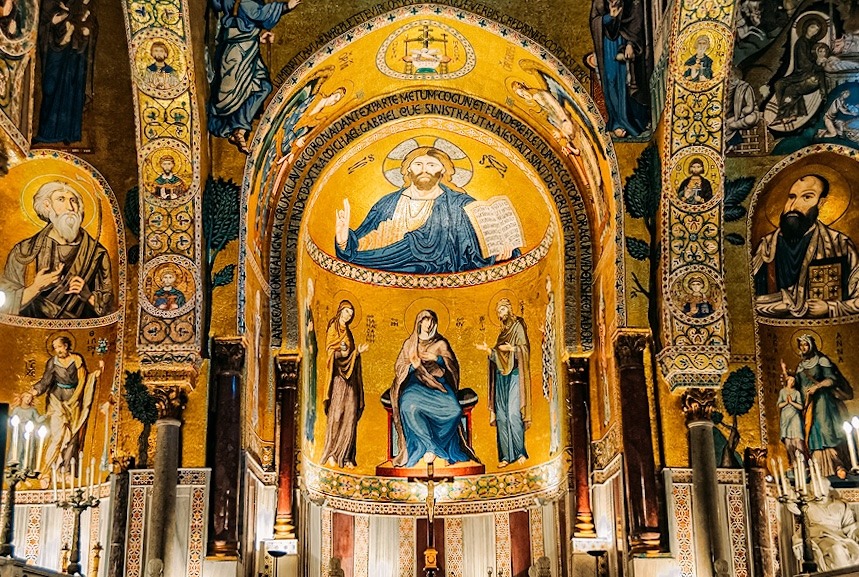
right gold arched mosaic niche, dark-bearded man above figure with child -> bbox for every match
[747,145,859,475]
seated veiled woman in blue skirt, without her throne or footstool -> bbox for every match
[391,310,477,467]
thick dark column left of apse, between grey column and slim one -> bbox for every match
[206,338,245,557]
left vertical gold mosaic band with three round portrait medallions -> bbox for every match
[122,0,202,362]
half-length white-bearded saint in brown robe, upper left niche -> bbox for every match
[0,181,115,319]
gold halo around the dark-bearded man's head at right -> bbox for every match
[766,163,853,228]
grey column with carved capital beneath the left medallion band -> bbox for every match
[144,374,189,576]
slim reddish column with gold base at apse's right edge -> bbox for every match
[567,357,596,537]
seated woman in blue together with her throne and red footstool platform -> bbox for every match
[376,310,486,477]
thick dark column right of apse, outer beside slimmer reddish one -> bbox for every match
[614,334,664,552]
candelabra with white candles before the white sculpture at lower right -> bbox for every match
[770,451,829,573]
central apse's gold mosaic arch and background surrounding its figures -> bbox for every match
[239,4,625,510]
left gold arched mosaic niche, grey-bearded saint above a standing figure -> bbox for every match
[0,150,126,488]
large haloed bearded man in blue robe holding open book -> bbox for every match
[334,139,525,274]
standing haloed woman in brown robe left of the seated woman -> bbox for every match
[322,300,367,469]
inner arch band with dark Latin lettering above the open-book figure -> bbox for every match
[269,89,595,350]
